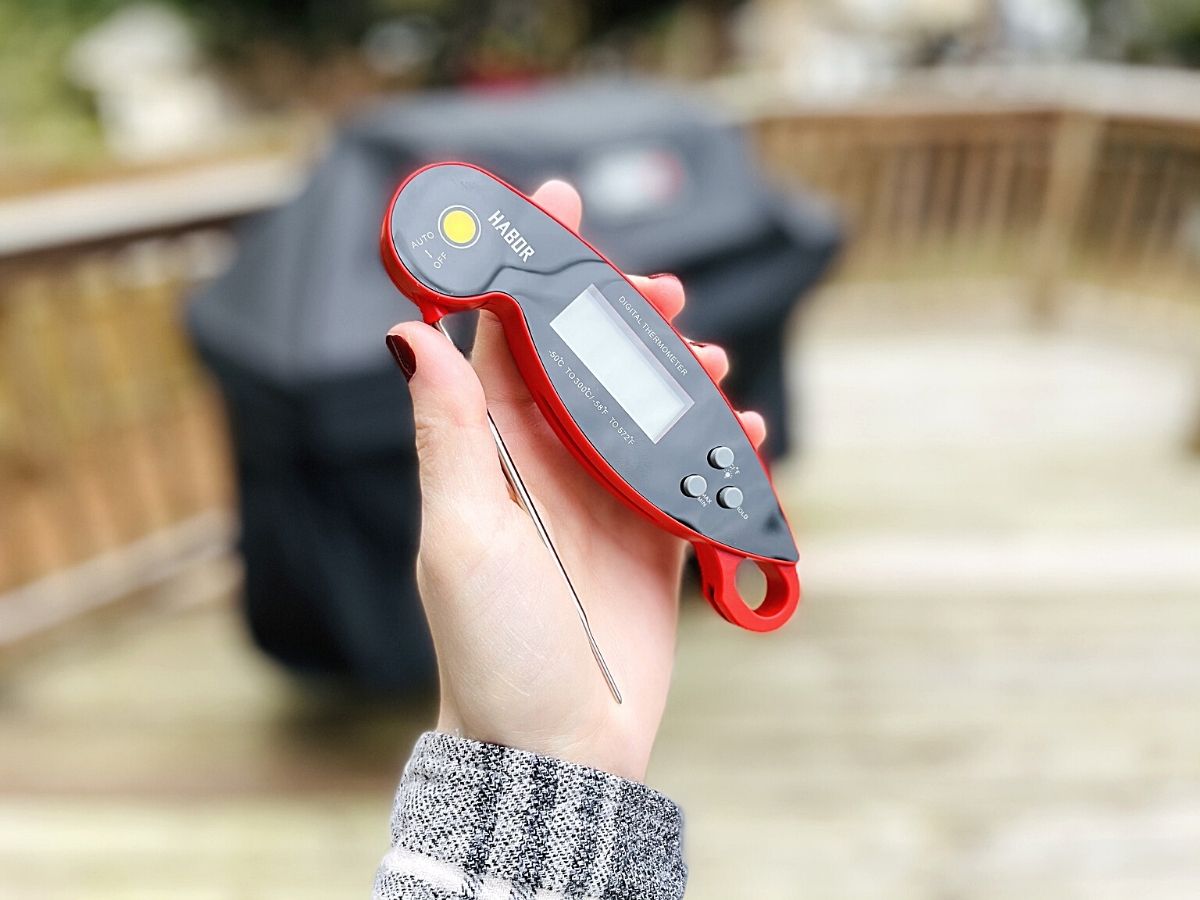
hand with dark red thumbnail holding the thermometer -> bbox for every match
[388,181,766,780]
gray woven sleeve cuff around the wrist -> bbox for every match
[373,732,688,900]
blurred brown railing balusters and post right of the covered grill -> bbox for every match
[756,105,1200,320]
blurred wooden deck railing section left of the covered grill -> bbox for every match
[0,160,296,646]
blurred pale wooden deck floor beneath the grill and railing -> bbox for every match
[0,321,1200,900]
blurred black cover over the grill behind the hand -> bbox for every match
[188,80,839,689]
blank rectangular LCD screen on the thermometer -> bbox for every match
[550,284,695,444]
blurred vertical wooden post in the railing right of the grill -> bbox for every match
[1030,112,1103,325]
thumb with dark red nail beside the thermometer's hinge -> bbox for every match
[388,322,508,516]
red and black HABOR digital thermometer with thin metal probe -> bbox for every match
[380,163,800,702]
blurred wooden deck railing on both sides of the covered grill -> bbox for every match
[0,72,1200,644]
